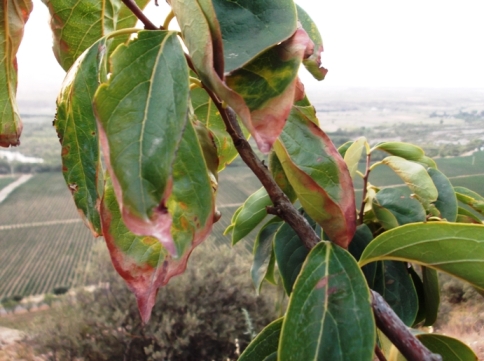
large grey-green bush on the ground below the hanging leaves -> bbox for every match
[32,241,277,361]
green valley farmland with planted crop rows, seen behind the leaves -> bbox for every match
[0,152,484,299]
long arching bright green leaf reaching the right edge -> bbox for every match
[359,222,484,289]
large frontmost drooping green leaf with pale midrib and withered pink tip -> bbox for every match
[94,31,190,255]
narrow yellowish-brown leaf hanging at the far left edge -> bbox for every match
[0,0,32,148]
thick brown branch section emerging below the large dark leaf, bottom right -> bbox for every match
[371,291,442,361]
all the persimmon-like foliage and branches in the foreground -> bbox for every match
[0,0,484,360]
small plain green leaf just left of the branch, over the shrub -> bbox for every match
[229,187,272,245]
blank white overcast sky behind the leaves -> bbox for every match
[18,0,484,104]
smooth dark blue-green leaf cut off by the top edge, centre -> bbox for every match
[212,0,297,73]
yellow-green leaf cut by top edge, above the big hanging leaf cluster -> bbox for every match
[42,0,149,71]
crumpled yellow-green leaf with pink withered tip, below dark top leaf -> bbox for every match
[226,28,312,152]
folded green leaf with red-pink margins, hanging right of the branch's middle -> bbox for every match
[274,109,356,248]
